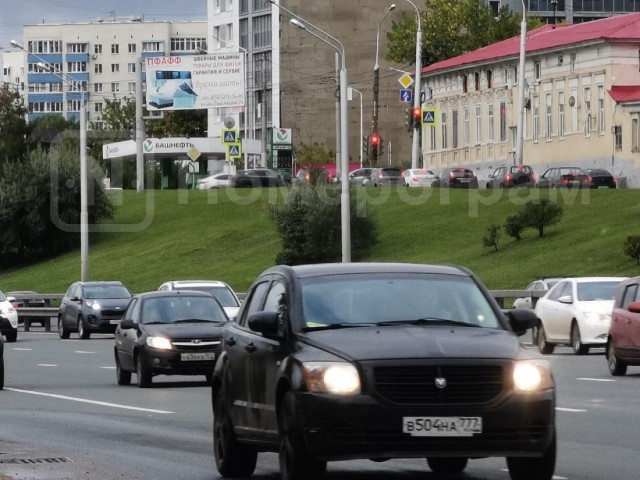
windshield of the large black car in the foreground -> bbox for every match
[302,274,501,329]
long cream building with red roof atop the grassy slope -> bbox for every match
[422,13,640,187]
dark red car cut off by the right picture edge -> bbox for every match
[607,277,640,376]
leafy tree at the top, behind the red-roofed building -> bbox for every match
[387,0,542,66]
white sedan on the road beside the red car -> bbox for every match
[535,277,626,355]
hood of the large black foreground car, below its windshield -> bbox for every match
[302,325,521,361]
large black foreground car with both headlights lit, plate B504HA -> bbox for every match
[212,263,556,480]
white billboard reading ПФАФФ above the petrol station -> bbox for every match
[145,53,246,110]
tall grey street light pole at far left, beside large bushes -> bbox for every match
[10,40,89,282]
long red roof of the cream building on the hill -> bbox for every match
[422,13,640,74]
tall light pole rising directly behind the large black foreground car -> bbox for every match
[267,0,351,263]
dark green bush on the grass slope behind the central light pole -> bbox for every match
[268,184,377,265]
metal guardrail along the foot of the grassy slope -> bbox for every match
[14,290,545,332]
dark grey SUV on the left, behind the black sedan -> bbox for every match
[58,281,131,340]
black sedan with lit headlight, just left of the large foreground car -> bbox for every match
[114,290,228,388]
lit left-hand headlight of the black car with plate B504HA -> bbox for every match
[302,362,360,395]
